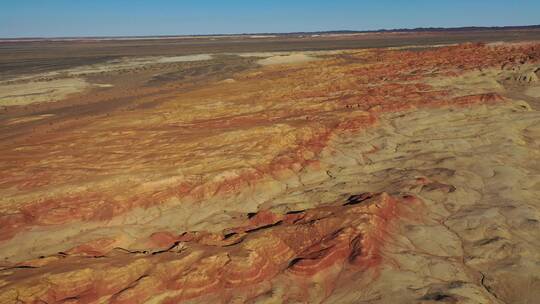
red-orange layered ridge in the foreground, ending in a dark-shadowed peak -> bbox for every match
[0,193,412,303]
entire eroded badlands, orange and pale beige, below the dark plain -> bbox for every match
[0,43,540,303]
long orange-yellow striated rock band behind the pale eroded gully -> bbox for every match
[0,44,540,248]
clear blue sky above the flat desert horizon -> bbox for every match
[0,0,540,37]
